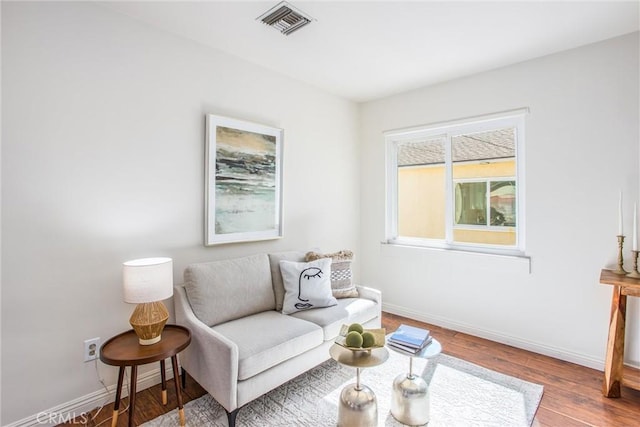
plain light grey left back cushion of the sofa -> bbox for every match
[184,254,275,326]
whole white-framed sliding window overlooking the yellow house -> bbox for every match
[385,110,526,254]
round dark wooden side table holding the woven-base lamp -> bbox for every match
[100,325,191,427]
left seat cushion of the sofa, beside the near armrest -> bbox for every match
[212,311,323,381]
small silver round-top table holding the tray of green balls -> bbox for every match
[329,344,389,427]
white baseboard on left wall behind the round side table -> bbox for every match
[4,363,173,427]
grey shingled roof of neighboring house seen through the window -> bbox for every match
[398,128,516,166]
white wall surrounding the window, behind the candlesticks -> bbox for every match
[360,33,640,368]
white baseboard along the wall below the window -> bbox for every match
[382,302,604,371]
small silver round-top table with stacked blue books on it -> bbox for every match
[387,338,442,426]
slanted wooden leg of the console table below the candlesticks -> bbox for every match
[602,286,627,397]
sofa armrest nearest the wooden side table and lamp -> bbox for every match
[173,285,238,412]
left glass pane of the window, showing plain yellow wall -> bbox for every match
[397,138,446,239]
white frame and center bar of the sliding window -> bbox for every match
[384,108,529,256]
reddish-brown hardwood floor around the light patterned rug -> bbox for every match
[64,313,640,427]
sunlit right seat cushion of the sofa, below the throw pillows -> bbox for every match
[289,298,380,341]
